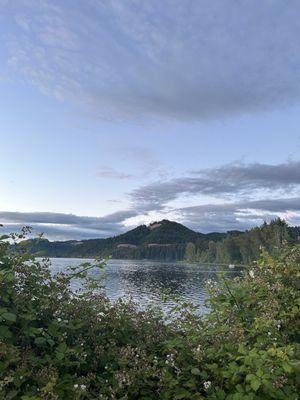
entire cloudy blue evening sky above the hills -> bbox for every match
[0,0,300,240]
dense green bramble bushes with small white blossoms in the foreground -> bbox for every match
[0,227,300,400]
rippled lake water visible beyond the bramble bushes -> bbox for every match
[51,258,241,314]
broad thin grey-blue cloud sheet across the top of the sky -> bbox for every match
[2,0,300,121]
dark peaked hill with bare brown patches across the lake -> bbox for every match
[18,219,226,260]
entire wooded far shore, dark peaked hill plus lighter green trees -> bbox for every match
[17,219,300,264]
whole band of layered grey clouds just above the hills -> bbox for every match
[0,161,300,239]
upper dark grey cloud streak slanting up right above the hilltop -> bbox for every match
[131,161,300,210]
